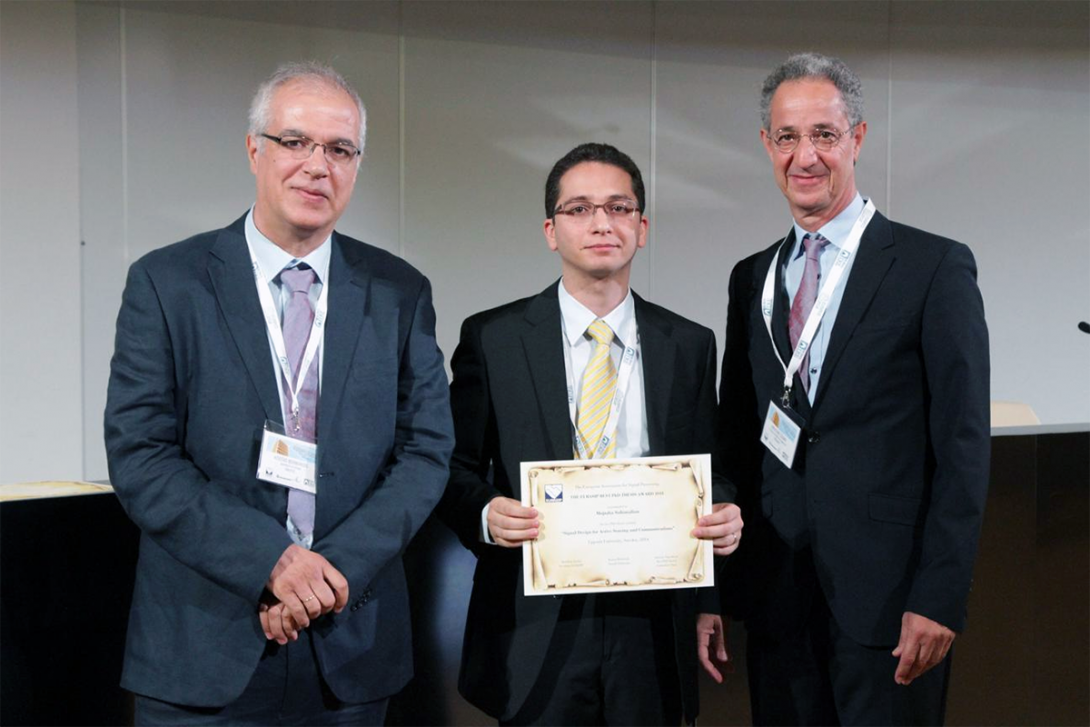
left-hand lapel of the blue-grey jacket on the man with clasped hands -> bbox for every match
[208,217,282,423]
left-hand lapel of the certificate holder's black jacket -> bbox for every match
[522,283,572,459]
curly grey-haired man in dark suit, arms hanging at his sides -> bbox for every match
[719,53,990,727]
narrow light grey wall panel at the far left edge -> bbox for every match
[0,0,85,482]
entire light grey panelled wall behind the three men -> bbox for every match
[0,0,1090,480]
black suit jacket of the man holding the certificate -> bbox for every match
[438,283,732,719]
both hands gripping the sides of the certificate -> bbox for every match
[486,497,744,556]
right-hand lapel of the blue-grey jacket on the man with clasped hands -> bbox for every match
[318,232,368,441]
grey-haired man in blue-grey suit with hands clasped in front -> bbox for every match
[106,63,453,727]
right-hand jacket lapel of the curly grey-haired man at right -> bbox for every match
[814,214,896,408]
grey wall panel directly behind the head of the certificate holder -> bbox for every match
[403,0,654,364]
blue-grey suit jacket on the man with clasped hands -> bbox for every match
[106,213,452,705]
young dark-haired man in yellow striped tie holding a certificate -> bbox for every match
[439,144,742,727]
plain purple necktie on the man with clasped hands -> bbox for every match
[280,267,318,537]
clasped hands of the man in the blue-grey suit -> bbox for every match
[257,544,348,645]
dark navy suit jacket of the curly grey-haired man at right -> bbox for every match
[719,215,991,646]
